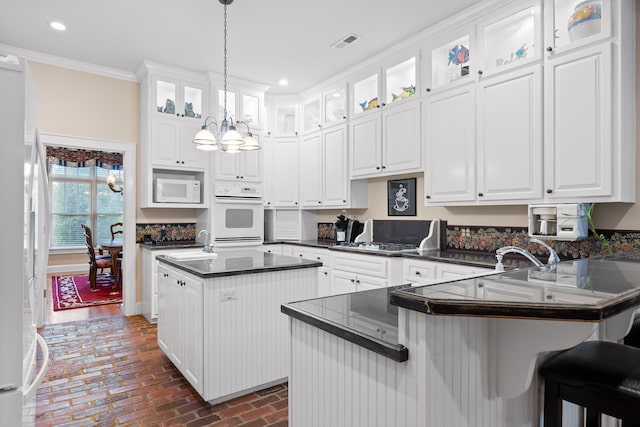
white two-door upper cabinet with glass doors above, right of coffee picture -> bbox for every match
[425,1,543,205]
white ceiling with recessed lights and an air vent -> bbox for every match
[0,0,481,94]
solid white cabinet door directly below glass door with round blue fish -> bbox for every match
[424,84,476,204]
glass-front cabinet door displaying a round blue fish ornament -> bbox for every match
[424,32,476,92]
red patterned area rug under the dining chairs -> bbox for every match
[51,274,122,311]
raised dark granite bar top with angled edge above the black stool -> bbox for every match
[391,252,640,322]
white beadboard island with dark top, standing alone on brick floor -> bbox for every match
[157,250,322,403]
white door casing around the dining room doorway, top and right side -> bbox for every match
[40,133,138,316]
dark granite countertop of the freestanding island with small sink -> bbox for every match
[158,250,322,278]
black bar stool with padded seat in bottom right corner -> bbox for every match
[539,341,640,427]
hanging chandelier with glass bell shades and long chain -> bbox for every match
[193,0,260,153]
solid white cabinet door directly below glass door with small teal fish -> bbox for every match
[476,63,543,203]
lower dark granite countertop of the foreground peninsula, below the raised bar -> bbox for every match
[281,287,409,362]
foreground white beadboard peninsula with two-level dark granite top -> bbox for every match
[282,253,640,427]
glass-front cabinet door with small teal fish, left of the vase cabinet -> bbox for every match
[478,1,542,76]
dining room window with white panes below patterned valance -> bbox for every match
[49,164,124,249]
